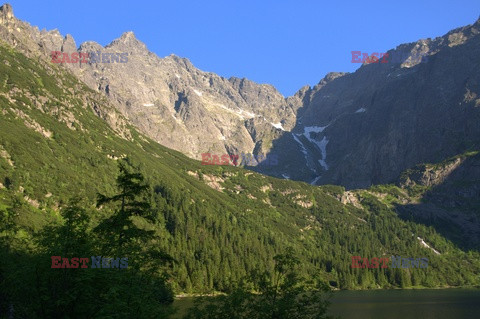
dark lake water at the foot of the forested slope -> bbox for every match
[175,289,480,319]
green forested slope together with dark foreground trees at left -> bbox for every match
[0,45,480,318]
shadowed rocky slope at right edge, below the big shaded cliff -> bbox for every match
[397,152,480,249]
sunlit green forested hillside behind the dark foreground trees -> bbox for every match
[0,40,480,302]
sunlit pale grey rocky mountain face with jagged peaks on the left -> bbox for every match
[0,7,302,165]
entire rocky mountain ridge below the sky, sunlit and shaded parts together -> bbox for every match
[0,5,480,192]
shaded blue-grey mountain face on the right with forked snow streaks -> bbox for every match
[265,16,480,188]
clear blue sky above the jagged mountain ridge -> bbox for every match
[9,0,480,96]
